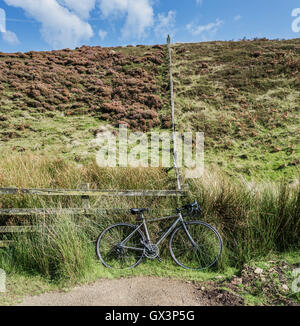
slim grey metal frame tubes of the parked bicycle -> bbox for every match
[120,213,197,251]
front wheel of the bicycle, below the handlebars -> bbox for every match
[170,221,223,270]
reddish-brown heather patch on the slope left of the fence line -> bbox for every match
[0,46,169,135]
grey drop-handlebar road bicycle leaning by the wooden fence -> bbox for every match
[96,201,223,270]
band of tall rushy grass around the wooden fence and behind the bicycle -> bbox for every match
[0,154,300,304]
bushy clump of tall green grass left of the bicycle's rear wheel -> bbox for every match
[3,216,93,283]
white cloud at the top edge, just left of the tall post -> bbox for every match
[99,0,154,38]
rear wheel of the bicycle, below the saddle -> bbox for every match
[96,223,144,269]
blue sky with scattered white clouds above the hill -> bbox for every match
[0,0,300,52]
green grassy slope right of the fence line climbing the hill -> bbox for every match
[173,39,300,182]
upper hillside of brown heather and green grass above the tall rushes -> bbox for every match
[0,39,300,180]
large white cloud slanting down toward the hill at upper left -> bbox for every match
[4,0,93,49]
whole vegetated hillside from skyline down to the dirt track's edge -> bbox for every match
[0,39,300,305]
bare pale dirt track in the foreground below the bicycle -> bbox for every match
[15,277,210,306]
